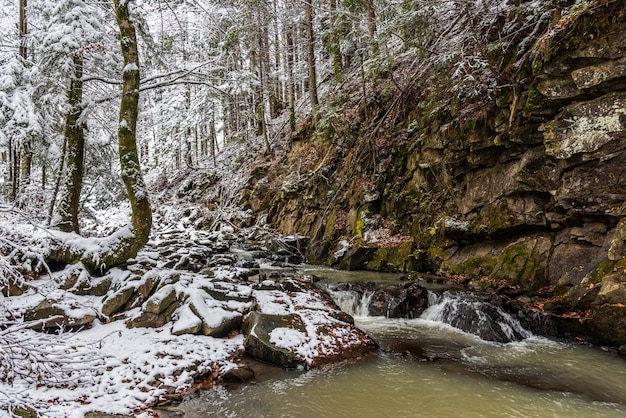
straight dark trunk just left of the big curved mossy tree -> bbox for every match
[57,53,85,234]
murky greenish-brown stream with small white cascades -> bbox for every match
[172,266,626,418]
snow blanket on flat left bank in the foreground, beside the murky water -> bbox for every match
[0,314,243,418]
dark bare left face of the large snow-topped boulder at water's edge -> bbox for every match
[242,311,306,368]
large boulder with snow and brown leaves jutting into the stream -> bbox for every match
[242,279,376,367]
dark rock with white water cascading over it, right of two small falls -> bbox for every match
[421,291,532,342]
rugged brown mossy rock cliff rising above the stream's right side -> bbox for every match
[244,1,626,344]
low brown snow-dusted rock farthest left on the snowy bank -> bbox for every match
[24,299,97,330]
